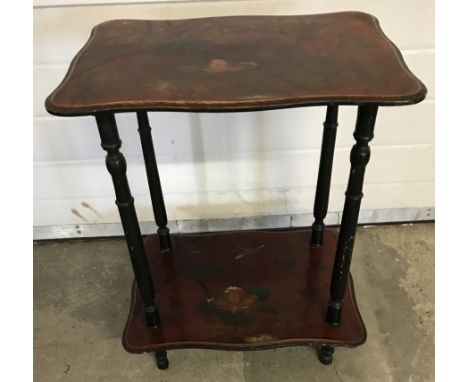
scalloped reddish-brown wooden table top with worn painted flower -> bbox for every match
[46,12,426,116]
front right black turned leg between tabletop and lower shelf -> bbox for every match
[326,105,377,325]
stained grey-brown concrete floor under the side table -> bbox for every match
[34,223,434,382]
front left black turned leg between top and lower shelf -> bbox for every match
[96,113,160,329]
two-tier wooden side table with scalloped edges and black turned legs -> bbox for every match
[46,12,426,369]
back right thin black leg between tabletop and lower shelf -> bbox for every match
[310,105,338,247]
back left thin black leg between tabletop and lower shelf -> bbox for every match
[137,111,171,252]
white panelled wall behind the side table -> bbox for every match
[34,0,434,236]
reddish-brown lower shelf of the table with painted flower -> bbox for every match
[122,230,366,353]
